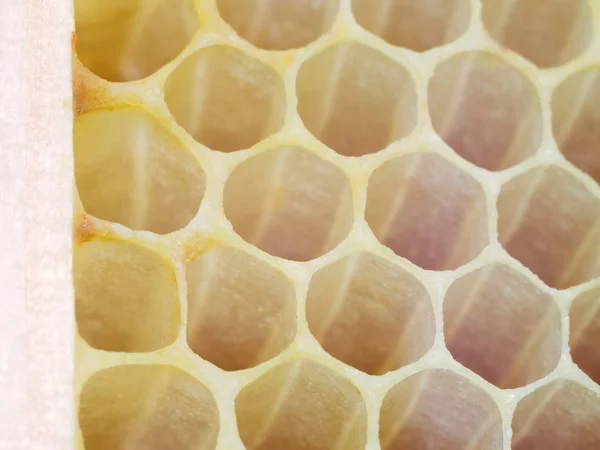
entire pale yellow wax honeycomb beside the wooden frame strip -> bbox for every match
[73,0,600,450]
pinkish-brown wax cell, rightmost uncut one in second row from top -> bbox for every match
[429,52,542,170]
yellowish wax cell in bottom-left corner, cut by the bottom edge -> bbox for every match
[79,365,219,450]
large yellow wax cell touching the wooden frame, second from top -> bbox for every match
[73,109,205,234]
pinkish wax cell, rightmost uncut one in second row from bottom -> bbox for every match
[444,263,562,389]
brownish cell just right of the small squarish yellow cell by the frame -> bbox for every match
[186,248,296,370]
